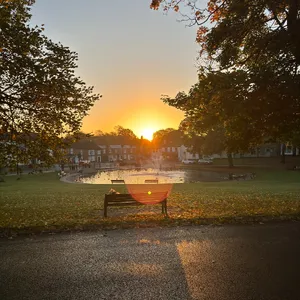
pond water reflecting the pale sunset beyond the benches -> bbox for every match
[80,169,228,184]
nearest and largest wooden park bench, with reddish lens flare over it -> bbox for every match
[104,192,168,218]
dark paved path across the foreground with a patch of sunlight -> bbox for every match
[0,223,300,300]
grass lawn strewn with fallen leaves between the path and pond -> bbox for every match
[0,170,300,234]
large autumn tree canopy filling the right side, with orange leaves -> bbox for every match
[151,0,300,161]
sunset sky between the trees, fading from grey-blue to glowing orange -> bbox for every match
[32,0,199,136]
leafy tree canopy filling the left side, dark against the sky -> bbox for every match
[0,0,99,168]
